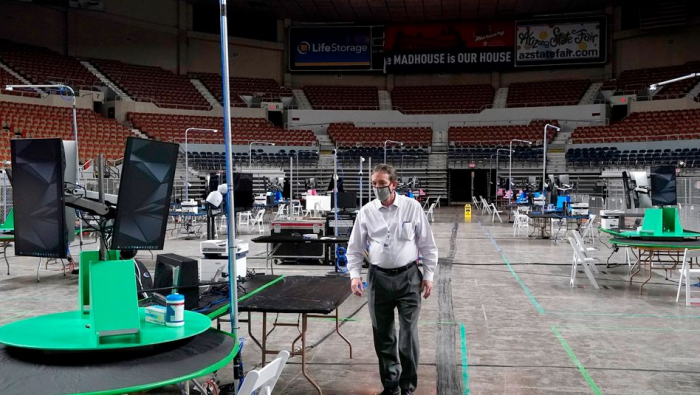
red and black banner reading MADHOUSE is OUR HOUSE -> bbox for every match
[384,22,514,73]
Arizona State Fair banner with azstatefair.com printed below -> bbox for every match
[515,17,607,67]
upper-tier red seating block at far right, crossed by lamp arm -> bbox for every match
[600,62,700,99]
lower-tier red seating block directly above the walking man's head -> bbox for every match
[328,123,433,149]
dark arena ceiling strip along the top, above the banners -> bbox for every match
[224,0,617,23]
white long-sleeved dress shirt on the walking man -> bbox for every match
[347,194,438,281]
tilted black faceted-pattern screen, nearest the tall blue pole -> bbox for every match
[111,138,178,250]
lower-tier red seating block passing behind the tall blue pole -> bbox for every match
[127,113,316,146]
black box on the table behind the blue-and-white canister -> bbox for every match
[153,254,199,310]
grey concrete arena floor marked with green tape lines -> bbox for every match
[0,207,700,395]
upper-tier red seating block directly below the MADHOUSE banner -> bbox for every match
[391,84,494,114]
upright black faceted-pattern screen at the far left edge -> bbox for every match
[10,139,68,258]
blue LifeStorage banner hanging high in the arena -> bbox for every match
[289,26,372,71]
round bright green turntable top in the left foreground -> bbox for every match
[0,308,211,351]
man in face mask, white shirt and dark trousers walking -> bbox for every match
[347,164,438,395]
